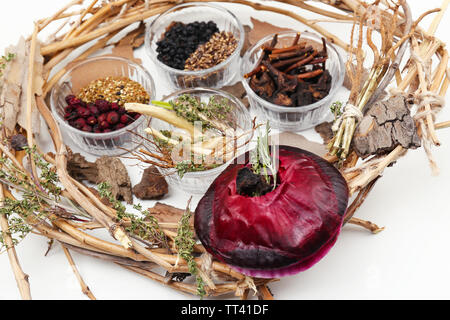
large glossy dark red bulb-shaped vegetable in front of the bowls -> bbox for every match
[194,146,348,278]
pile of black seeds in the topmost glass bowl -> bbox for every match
[156,21,219,70]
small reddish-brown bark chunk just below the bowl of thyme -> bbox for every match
[133,166,169,200]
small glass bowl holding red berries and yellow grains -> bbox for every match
[50,56,155,156]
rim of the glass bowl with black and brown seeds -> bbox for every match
[145,2,245,76]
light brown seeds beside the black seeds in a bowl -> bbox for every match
[184,31,238,71]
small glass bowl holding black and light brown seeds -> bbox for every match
[145,2,245,90]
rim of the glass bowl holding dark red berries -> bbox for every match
[50,56,155,139]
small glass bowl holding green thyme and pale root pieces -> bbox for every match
[147,88,253,195]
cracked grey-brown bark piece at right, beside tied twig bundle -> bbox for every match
[353,96,420,159]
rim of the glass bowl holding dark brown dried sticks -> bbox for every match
[241,31,345,113]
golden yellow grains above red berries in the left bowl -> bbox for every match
[77,77,150,106]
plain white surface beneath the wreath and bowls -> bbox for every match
[0,0,450,300]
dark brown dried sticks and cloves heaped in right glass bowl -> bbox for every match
[244,33,331,107]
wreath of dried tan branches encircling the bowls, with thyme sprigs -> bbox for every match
[0,0,450,299]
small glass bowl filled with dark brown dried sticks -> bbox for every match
[242,31,345,132]
